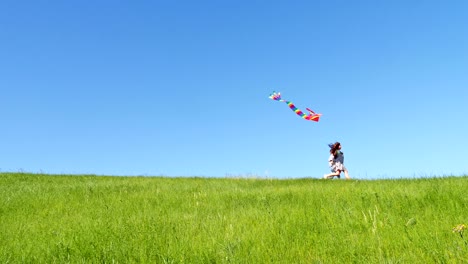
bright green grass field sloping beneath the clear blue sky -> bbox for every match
[0,173,468,263]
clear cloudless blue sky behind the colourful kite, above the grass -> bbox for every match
[0,0,468,179]
